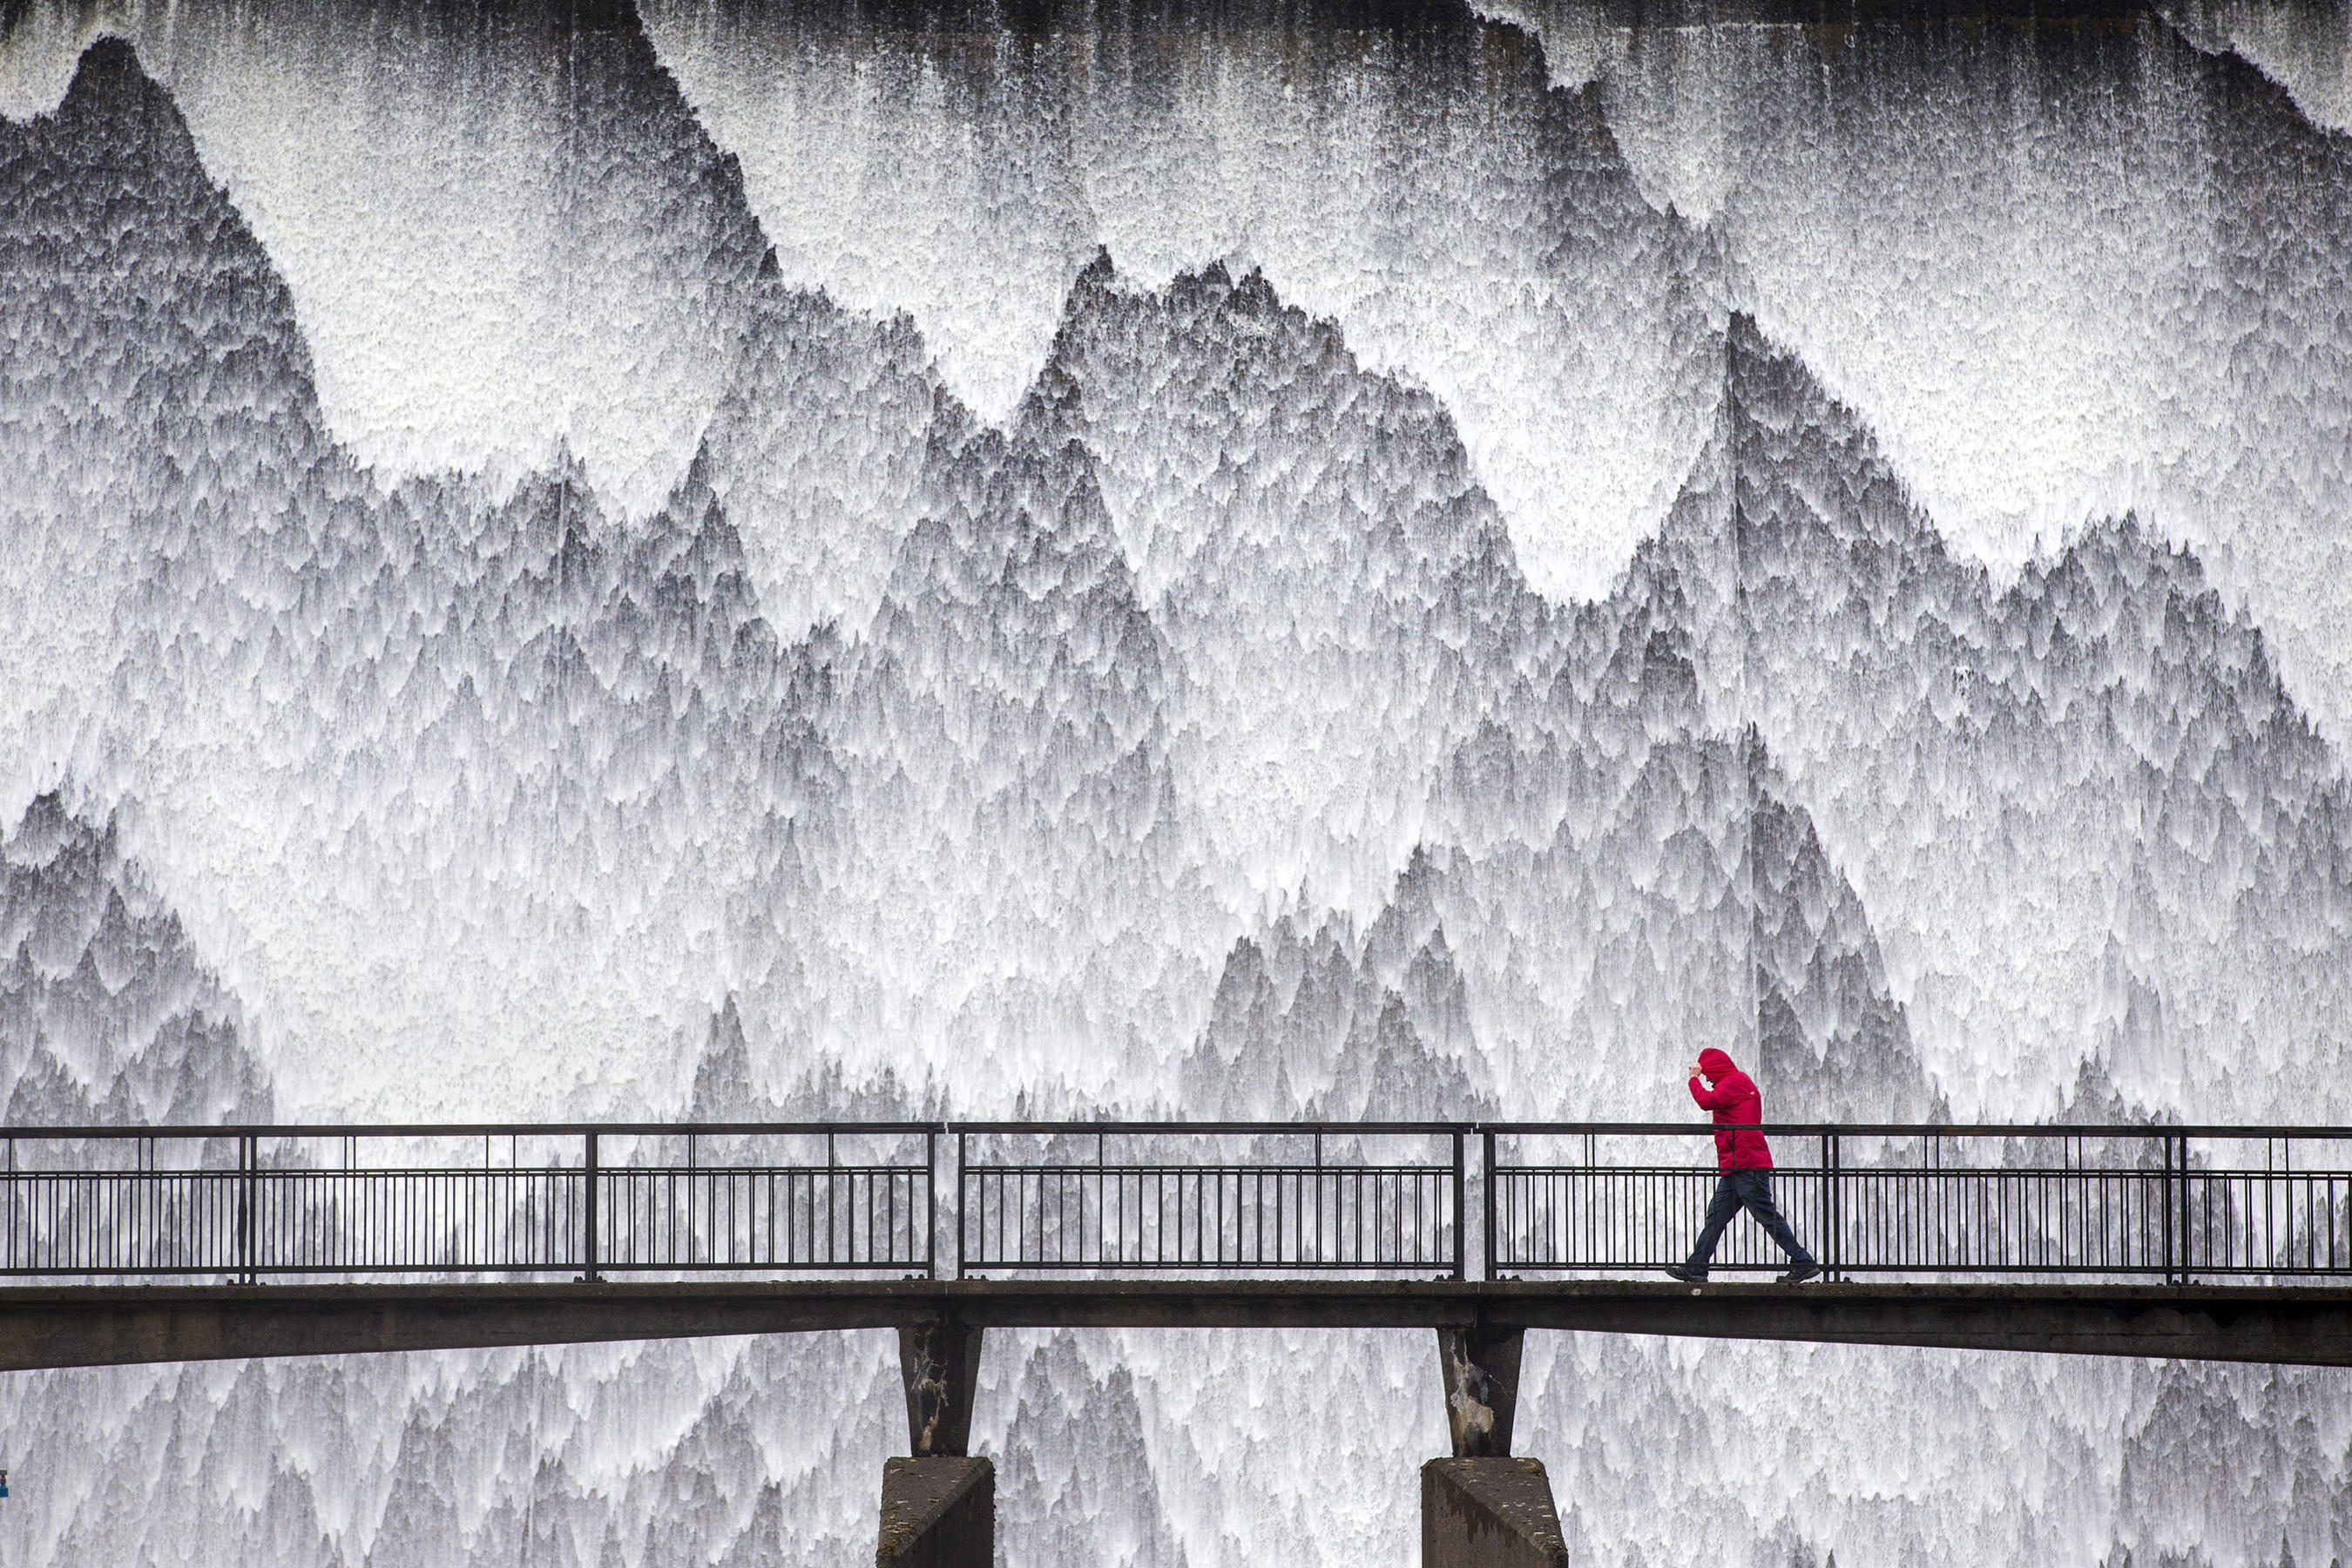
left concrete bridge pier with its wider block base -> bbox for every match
[875,1316,997,1568]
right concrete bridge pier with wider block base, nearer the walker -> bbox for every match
[1421,1326,1569,1568]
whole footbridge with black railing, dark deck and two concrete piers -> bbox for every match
[0,1121,2352,1565]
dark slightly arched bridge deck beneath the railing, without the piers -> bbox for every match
[0,1279,2352,1370]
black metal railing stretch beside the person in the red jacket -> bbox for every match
[1479,1124,2352,1281]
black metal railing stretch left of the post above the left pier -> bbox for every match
[0,1121,936,1283]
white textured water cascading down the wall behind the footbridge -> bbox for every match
[0,0,2352,1568]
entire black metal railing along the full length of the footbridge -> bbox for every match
[0,1121,2352,1283]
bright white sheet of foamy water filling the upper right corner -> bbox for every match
[1498,4,2352,761]
